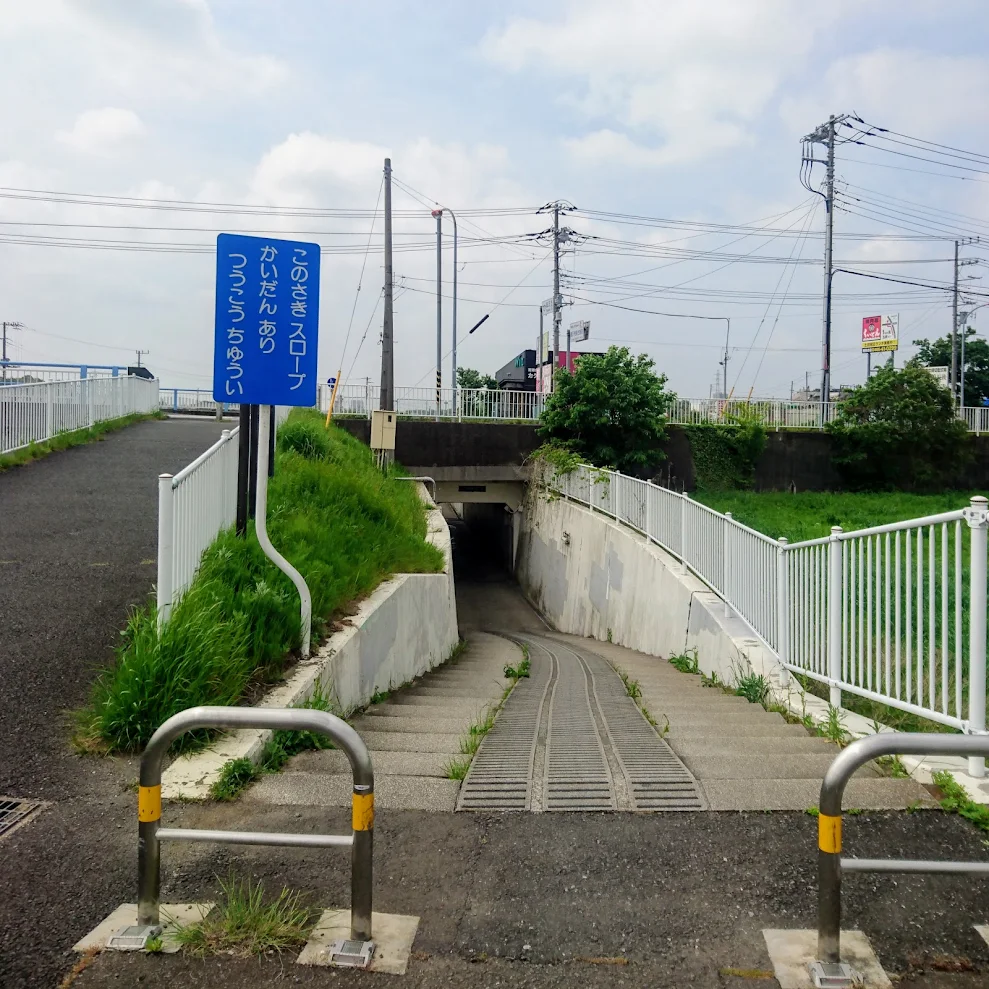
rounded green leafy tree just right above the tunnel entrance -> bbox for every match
[539,347,674,474]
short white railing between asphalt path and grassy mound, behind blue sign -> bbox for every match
[157,427,240,623]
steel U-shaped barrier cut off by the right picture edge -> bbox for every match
[815,732,989,985]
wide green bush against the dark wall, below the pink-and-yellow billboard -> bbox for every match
[827,359,971,490]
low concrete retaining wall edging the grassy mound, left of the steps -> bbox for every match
[162,494,460,800]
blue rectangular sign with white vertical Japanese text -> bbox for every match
[213,234,319,406]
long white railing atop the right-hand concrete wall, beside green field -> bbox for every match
[549,467,989,756]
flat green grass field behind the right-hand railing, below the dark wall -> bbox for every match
[692,491,984,543]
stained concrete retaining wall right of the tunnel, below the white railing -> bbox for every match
[516,492,785,684]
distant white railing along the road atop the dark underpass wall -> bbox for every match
[310,382,989,433]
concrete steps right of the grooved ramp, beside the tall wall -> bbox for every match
[553,635,933,811]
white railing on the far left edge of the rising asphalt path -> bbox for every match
[0,377,158,453]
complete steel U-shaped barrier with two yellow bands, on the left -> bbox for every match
[137,707,374,942]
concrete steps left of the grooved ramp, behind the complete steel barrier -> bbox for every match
[245,633,522,811]
